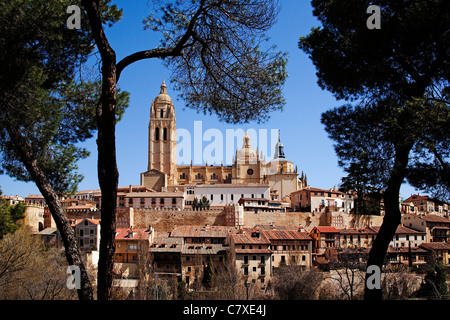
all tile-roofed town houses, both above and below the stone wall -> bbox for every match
[4,188,450,285]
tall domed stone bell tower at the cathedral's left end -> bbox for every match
[141,81,177,191]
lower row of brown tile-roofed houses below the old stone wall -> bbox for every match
[65,215,450,285]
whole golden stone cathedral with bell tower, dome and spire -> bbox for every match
[141,81,307,201]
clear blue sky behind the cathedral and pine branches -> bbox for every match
[0,0,415,198]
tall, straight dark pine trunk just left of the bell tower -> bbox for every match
[83,0,119,300]
